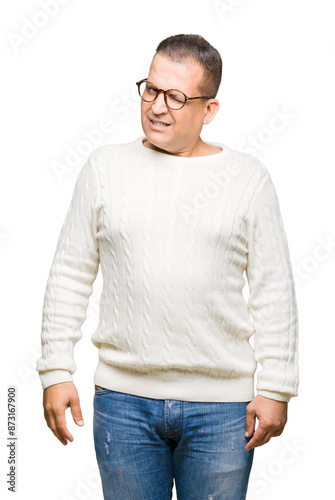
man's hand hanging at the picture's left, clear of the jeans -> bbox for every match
[43,382,84,446]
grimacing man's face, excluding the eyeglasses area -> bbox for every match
[141,53,214,154]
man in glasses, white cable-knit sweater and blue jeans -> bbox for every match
[37,35,299,500]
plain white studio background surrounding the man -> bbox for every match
[0,0,335,500]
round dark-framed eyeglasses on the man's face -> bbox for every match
[136,78,212,110]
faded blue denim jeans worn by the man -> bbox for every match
[93,386,254,500]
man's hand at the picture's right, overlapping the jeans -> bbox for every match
[245,394,287,451]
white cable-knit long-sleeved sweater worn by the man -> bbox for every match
[36,136,299,402]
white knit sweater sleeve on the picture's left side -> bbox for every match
[36,155,99,389]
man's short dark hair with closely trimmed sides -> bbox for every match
[155,35,222,98]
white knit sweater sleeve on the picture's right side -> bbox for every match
[246,173,299,402]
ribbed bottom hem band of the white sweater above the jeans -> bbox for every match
[94,360,254,403]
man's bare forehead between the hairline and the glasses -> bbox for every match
[148,53,203,95]
